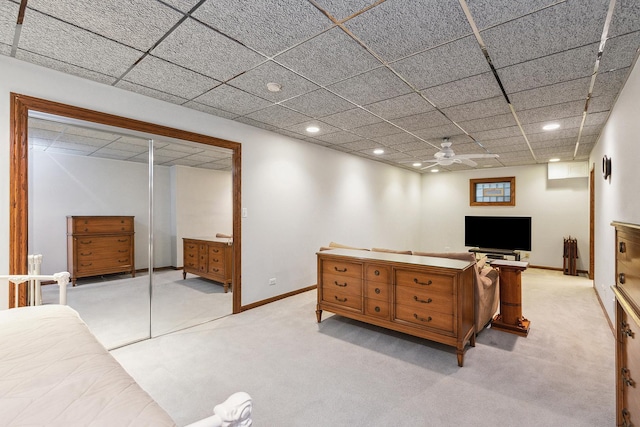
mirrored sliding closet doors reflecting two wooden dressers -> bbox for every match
[21,102,239,349]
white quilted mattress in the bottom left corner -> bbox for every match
[0,305,175,427]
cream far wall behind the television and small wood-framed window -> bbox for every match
[420,164,589,270]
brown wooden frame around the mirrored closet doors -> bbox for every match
[9,92,242,314]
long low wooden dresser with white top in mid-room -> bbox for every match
[316,249,475,366]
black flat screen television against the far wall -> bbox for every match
[464,216,531,251]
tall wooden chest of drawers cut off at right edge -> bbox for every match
[612,222,640,427]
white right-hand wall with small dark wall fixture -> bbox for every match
[590,59,640,322]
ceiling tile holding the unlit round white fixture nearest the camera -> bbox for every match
[227,61,318,102]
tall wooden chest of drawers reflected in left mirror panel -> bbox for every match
[67,216,136,286]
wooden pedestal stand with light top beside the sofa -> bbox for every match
[491,260,531,337]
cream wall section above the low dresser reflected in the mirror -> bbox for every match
[171,166,233,267]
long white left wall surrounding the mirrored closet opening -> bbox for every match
[0,56,420,307]
